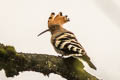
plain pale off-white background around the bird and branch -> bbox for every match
[0,0,120,80]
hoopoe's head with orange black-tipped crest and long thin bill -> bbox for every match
[38,12,70,36]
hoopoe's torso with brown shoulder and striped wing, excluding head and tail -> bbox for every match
[51,28,86,55]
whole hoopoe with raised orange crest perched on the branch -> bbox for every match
[38,12,96,70]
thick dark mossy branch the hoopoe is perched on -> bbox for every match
[0,44,98,80]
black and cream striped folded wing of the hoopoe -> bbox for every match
[53,32,86,56]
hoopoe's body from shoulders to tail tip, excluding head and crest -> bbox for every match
[51,29,96,70]
